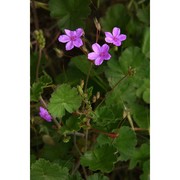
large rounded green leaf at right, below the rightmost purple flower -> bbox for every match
[106,47,149,88]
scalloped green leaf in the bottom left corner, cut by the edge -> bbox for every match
[31,159,68,180]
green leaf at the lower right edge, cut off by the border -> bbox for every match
[129,144,150,169]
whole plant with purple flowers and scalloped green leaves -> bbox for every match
[31,0,150,180]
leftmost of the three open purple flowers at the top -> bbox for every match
[58,28,84,51]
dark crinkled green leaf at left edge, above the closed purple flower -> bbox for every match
[30,72,52,102]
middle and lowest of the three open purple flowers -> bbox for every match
[88,43,111,66]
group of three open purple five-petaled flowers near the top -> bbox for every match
[58,27,126,66]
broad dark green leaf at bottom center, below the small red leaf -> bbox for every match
[81,145,116,173]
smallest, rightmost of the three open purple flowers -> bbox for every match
[105,27,126,46]
